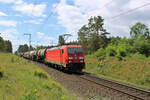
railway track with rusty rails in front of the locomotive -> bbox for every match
[79,74,150,100]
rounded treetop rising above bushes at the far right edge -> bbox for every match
[130,22,150,39]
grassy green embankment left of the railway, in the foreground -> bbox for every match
[0,53,76,100]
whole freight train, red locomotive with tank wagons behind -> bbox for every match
[19,45,85,72]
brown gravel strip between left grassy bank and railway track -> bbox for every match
[32,62,136,100]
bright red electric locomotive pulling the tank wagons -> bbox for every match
[44,45,85,71]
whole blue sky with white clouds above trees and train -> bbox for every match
[0,0,150,51]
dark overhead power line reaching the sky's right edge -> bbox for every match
[108,3,150,20]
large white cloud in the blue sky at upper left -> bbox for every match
[13,3,46,17]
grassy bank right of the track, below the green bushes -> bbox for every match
[84,56,150,89]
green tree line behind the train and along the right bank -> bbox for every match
[18,16,150,57]
